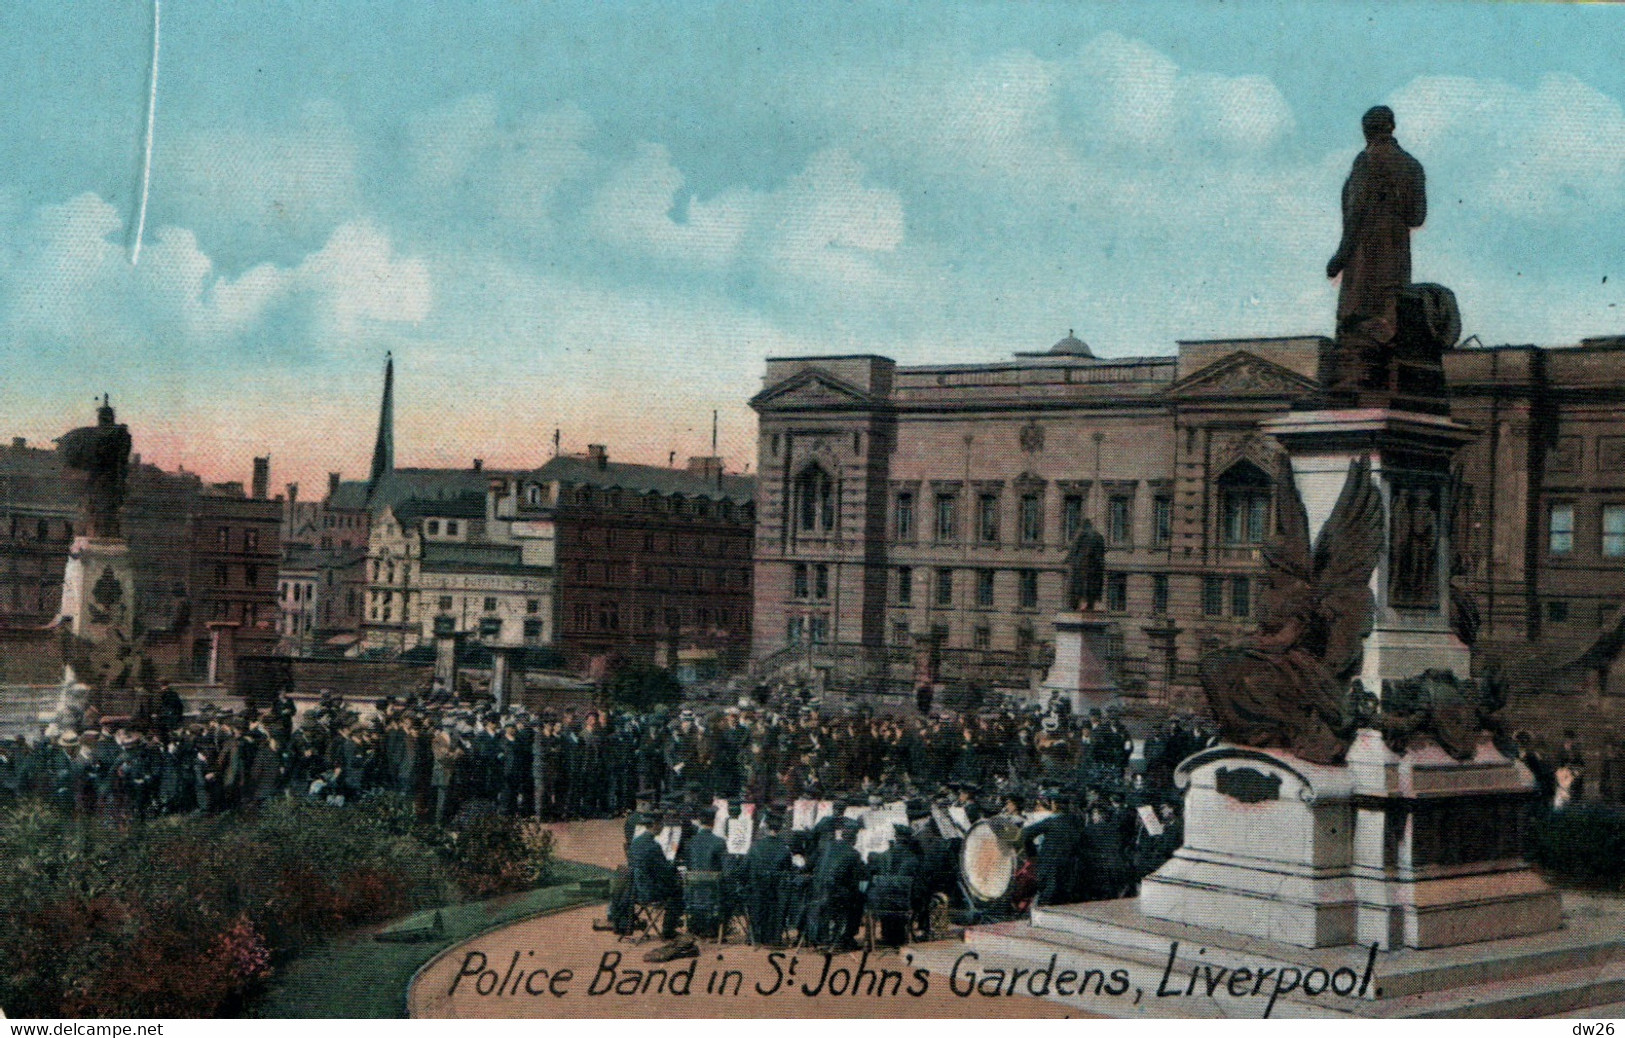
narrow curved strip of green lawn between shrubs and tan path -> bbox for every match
[249,861,613,1019]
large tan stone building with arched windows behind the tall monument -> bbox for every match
[752,335,1625,721]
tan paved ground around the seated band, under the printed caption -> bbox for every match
[408,820,1077,1019]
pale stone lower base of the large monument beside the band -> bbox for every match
[1139,731,1562,949]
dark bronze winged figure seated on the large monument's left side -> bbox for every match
[1201,458,1386,763]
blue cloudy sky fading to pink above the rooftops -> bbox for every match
[0,0,1625,487]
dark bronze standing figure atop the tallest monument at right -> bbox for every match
[1326,106,1427,395]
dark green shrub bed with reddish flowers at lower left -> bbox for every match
[0,794,553,1017]
